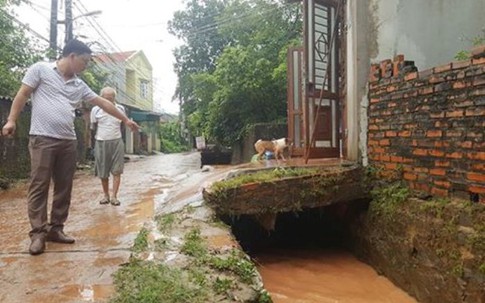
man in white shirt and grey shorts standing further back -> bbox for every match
[91,87,125,205]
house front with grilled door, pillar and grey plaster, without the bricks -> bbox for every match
[288,0,485,163]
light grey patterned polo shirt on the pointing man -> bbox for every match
[22,62,97,140]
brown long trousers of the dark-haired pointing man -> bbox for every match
[28,136,77,238]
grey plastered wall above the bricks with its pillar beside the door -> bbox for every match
[344,0,485,165]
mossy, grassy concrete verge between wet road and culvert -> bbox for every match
[107,205,271,303]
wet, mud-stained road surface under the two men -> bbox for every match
[0,153,223,303]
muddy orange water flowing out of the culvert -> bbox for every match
[254,249,417,303]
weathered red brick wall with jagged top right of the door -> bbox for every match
[368,46,485,202]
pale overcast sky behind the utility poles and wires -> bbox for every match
[16,0,184,114]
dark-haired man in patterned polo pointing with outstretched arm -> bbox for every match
[2,40,138,255]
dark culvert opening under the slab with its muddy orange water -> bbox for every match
[216,200,417,303]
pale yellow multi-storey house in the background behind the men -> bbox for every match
[94,50,161,154]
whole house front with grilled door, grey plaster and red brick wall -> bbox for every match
[288,0,485,202]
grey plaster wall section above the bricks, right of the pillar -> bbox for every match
[369,0,485,70]
